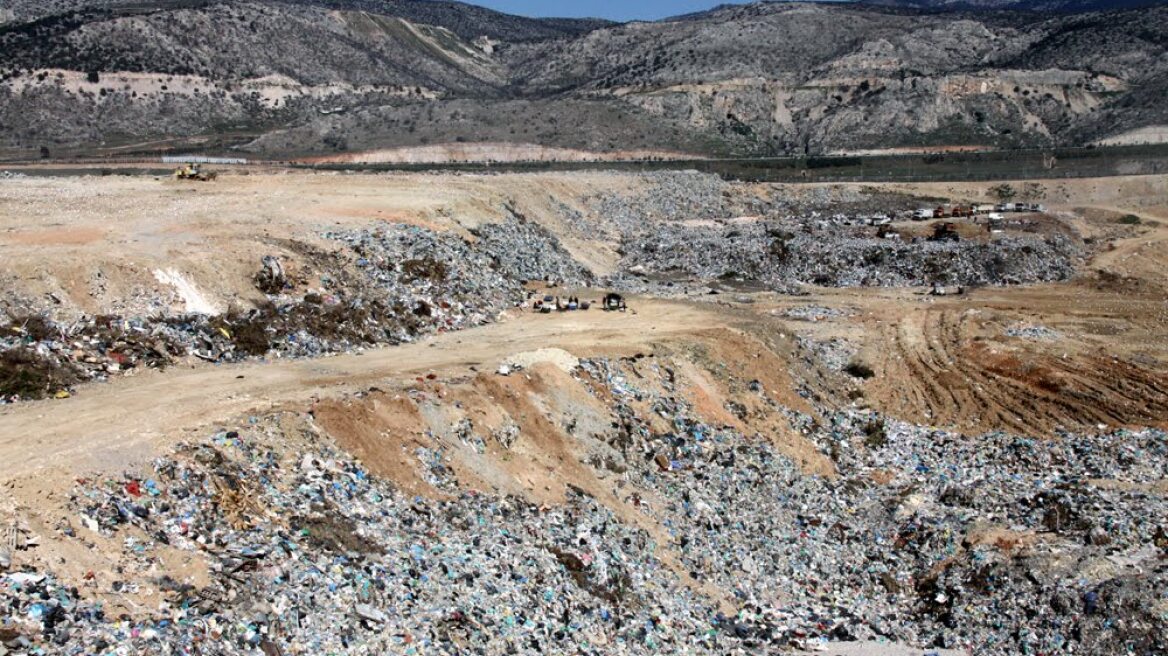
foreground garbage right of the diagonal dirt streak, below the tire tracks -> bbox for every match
[569,361,1168,654]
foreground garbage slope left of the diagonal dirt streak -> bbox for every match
[0,419,737,656]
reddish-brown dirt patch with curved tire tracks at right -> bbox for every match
[867,306,1168,434]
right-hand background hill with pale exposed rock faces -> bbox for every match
[516,5,1166,154]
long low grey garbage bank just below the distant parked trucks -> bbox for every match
[621,222,1078,289]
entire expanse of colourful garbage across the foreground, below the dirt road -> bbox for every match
[0,357,1168,655]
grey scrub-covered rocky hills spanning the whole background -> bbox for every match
[0,0,1168,156]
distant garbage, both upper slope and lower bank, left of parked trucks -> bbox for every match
[559,172,1082,290]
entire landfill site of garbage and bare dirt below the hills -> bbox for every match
[0,166,1168,656]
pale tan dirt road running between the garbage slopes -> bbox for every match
[0,300,719,479]
